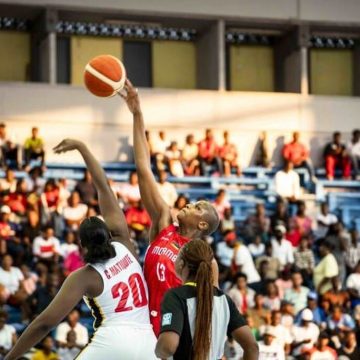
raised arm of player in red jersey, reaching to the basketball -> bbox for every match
[120,80,171,241]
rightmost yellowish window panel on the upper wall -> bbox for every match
[310,49,354,96]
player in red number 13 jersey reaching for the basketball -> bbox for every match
[120,80,219,336]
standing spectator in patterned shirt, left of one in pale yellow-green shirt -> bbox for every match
[294,236,315,287]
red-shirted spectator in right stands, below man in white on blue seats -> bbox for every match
[287,201,312,247]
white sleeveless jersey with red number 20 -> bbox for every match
[84,242,150,329]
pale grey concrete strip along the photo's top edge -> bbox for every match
[0,0,360,23]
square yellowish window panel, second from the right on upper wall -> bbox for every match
[228,45,275,92]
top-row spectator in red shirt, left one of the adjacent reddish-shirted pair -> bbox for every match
[199,129,223,175]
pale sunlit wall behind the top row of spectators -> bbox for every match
[0,83,360,166]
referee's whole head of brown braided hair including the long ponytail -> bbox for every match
[181,240,214,360]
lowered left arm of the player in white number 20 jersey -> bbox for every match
[5,266,103,360]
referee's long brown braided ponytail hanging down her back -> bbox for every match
[193,261,214,360]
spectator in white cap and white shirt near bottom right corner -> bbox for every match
[292,309,320,356]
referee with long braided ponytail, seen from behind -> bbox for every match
[155,240,259,360]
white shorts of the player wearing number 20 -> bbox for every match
[75,325,157,360]
